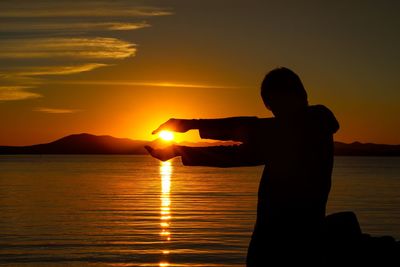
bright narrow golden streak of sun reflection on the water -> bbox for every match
[160,161,172,266]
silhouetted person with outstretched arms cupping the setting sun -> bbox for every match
[147,68,339,266]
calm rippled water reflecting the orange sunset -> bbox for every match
[0,156,400,267]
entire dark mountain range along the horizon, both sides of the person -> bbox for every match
[0,133,400,156]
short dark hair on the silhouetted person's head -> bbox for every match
[261,67,308,105]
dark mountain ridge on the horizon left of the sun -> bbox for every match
[0,133,148,154]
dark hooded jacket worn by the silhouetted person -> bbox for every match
[179,105,339,236]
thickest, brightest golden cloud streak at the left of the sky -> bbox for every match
[0,37,136,59]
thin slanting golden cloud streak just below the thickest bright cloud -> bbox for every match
[0,63,109,78]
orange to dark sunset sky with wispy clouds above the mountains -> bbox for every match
[0,0,400,145]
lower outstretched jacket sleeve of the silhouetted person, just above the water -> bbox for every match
[177,144,266,167]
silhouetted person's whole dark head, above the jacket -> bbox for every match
[261,67,308,117]
